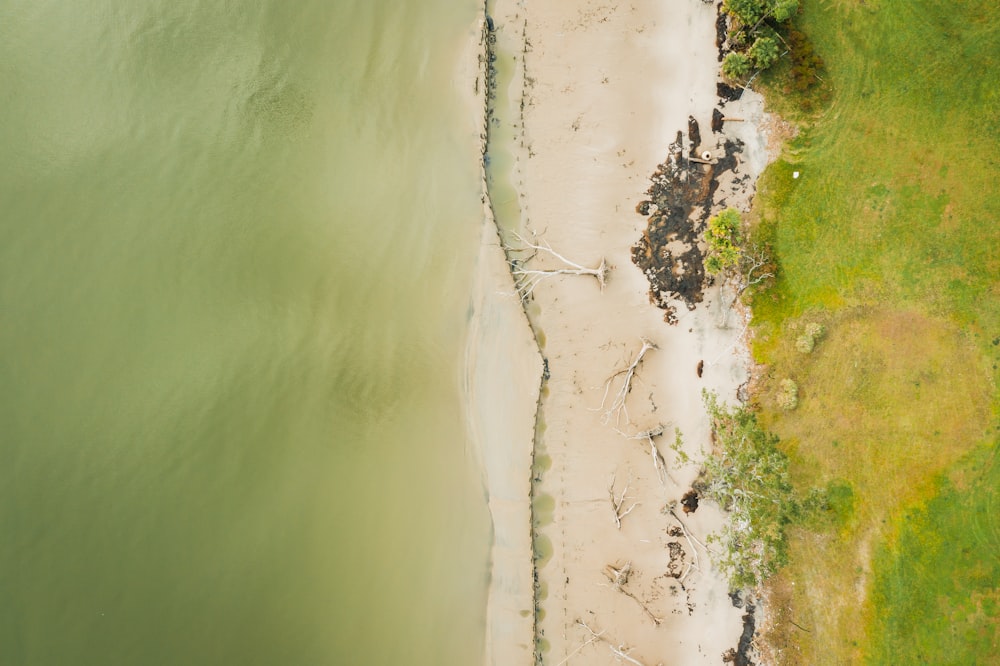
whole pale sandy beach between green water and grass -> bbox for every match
[470,0,766,666]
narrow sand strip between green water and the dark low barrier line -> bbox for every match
[458,12,543,666]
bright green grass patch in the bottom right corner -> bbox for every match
[866,450,1000,664]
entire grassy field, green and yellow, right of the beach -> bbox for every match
[752,0,1000,664]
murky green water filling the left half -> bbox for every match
[0,0,489,666]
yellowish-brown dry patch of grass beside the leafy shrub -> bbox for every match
[756,308,991,664]
